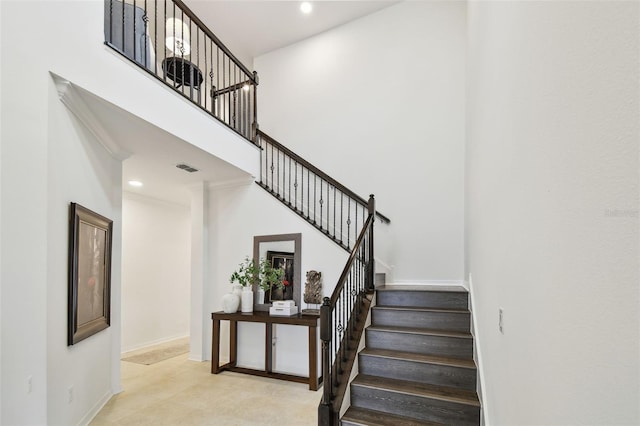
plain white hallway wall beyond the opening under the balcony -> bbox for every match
[122,192,191,352]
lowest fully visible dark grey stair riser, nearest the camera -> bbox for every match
[351,384,480,426]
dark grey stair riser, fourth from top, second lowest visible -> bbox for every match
[358,355,476,391]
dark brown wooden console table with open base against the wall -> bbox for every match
[211,311,322,390]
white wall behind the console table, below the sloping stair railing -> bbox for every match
[205,182,348,375]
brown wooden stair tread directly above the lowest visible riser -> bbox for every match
[351,374,480,407]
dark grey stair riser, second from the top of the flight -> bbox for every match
[371,308,470,332]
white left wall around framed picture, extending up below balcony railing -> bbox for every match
[0,0,258,425]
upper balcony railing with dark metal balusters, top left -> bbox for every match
[104,0,258,142]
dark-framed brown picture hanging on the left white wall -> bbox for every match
[67,203,113,346]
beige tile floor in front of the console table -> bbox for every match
[91,348,322,426]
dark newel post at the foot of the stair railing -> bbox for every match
[318,297,334,426]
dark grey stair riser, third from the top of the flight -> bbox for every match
[366,329,473,359]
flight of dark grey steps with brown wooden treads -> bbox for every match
[342,286,480,426]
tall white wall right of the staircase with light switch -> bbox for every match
[466,2,640,425]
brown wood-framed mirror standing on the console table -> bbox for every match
[253,233,303,311]
